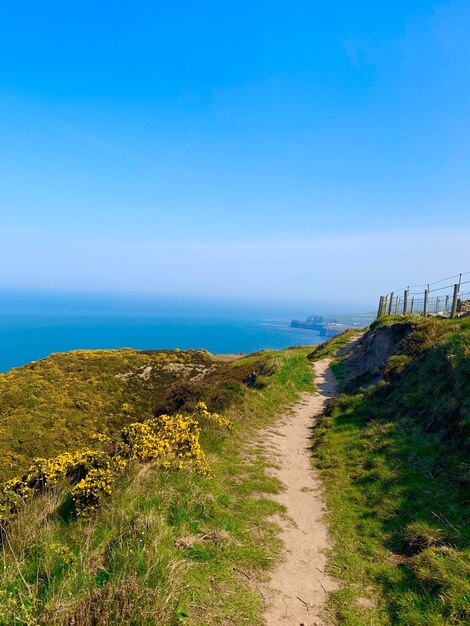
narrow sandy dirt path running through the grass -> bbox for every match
[263,360,336,626]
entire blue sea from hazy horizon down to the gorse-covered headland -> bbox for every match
[0,293,330,372]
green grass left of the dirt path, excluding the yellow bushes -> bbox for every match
[0,348,318,626]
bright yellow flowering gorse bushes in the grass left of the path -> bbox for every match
[0,402,232,524]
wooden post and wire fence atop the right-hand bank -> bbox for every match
[377,272,470,318]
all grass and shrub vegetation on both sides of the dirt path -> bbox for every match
[0,316,470,626]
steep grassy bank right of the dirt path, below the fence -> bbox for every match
[312,317,470,626]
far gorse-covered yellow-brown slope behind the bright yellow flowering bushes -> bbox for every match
[0,349,214,481]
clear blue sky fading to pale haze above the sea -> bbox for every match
[0,0,470,306]
